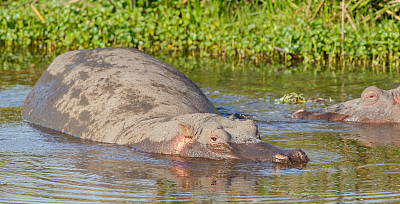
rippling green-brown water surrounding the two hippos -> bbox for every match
[0,51,400,203]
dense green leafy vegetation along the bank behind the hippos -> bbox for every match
[0,0,400,70]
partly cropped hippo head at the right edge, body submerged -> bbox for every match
[291,86,400,123]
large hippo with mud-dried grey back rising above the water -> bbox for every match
[22,48,308,163]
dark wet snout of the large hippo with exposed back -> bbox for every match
[231,142,309,164]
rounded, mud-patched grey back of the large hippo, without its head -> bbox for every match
[22,48,217,142]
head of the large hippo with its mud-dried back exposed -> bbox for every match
[131,113,308,163]
